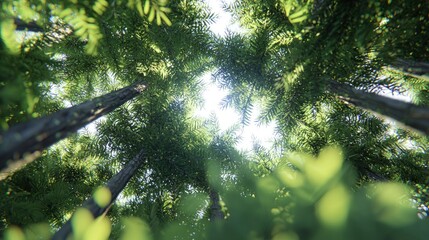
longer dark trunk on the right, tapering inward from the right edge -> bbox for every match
[328,81,429,135]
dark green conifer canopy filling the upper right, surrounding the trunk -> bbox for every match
[216,0,429,183]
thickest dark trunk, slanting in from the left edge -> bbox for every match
[0,82,146,180]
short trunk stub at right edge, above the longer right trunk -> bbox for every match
[389,58,429,81]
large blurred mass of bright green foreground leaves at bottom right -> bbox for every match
[201,148,427,239]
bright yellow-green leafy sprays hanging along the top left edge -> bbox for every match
[1,0,172,55]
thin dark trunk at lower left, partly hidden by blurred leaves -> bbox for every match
[52,150,144,240]
